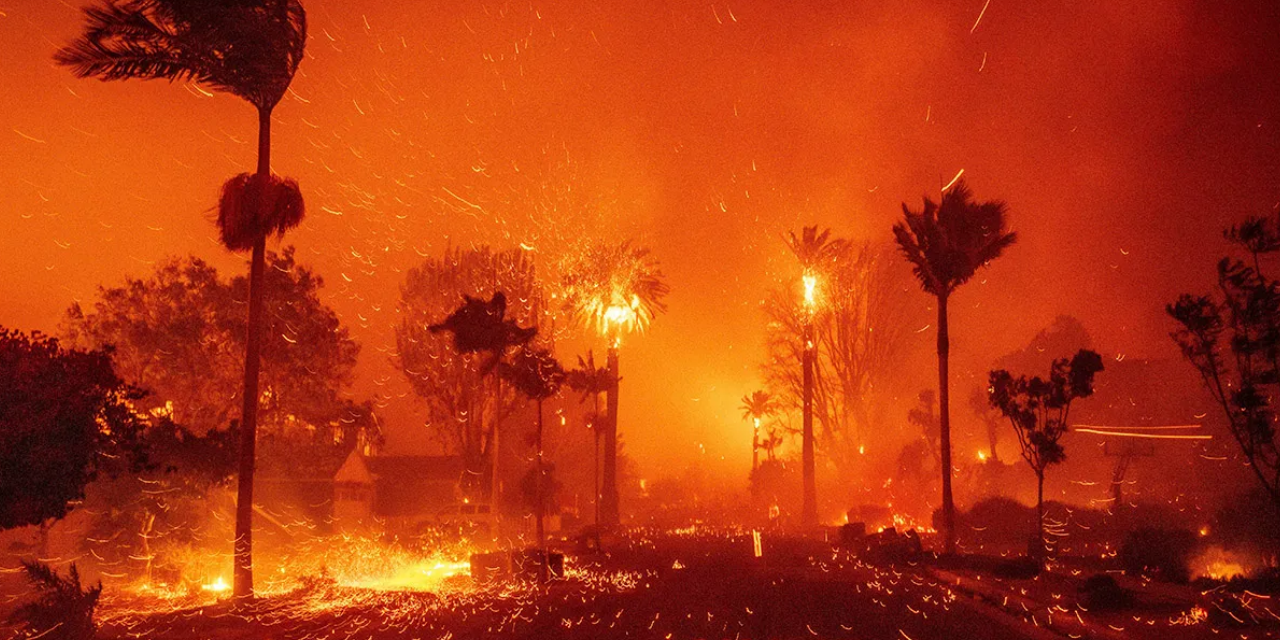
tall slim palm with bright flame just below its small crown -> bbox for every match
[787,227,845,526]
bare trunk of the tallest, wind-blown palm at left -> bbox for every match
[232,109,271,598]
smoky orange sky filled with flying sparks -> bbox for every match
[0,0,1280,481]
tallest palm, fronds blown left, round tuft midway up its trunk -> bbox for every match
[54,0,307,598]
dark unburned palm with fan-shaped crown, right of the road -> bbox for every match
[893,180,1018,553]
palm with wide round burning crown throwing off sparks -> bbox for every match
[563,242,671,527]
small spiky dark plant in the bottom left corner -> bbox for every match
[13,562,102,640]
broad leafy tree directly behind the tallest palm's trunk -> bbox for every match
[60,247,380,458]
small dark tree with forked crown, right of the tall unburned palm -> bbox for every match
[988,349,1102,556]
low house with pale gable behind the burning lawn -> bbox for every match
[333,452,466,531]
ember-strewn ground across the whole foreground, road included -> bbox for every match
[5,530,1275,640]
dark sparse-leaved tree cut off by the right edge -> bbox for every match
[1165,218,1280,509]
